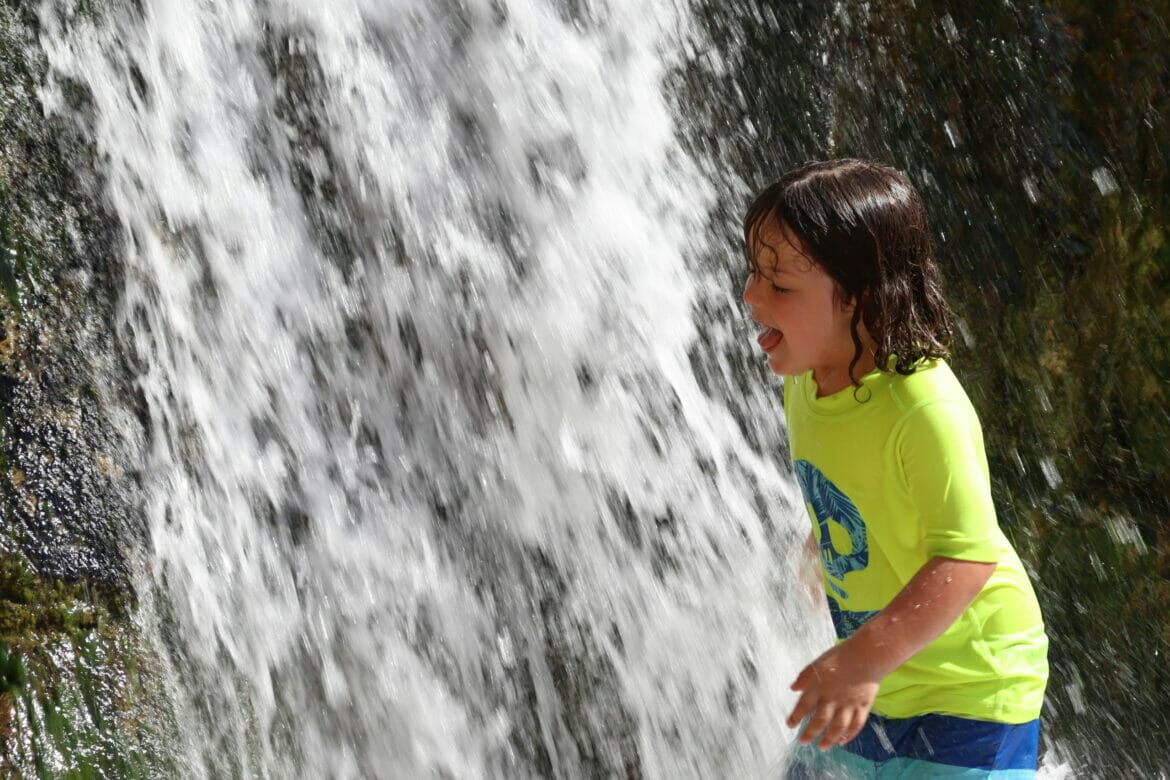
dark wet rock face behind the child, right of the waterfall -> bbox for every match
[680,0,1170,774]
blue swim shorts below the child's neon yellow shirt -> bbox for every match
[786,715,1040,780]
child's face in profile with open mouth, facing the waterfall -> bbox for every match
[743,221,872,395]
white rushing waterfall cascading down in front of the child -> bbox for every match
[41,0,830,778]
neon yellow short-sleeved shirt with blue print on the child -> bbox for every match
[784,360,1048,723]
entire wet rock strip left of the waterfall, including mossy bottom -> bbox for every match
[0,4,166,776]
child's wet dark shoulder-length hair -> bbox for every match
[743,159,951,386]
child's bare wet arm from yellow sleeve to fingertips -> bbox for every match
[787,558,996,750]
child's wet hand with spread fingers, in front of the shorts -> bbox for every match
[789,642,881,751]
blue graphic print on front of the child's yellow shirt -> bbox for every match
[794,461,878,640]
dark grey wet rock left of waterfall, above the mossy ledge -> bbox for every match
[0,7,132,586]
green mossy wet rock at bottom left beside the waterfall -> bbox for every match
[0,555,174,778]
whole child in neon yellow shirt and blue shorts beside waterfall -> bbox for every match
[743,160,1048,778]
